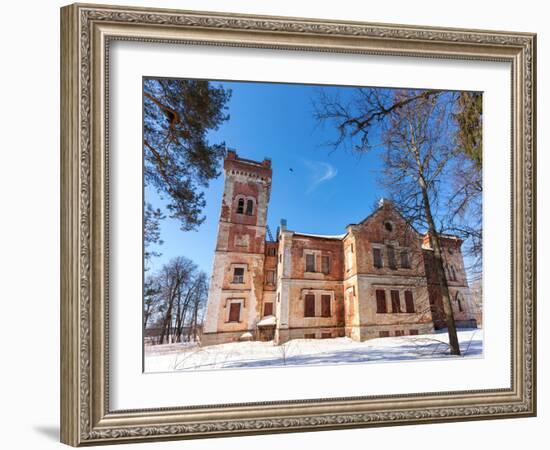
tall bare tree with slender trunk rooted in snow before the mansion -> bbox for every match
[316,88,468,355]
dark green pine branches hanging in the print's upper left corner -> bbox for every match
[143,79,231,231]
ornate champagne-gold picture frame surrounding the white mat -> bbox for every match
[61,4,536,446]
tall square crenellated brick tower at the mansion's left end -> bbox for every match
[201,151,272,345]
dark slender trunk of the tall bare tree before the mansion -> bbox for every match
[420,179,460,355]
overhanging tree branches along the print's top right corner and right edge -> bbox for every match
[315,88,483,268]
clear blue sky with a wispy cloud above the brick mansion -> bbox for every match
[145,82,416,274]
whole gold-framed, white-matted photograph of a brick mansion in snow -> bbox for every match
[61,4,536,446]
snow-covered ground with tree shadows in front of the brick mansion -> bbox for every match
[145,329,483,372]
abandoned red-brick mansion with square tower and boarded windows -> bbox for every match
[201,151,476,345]
